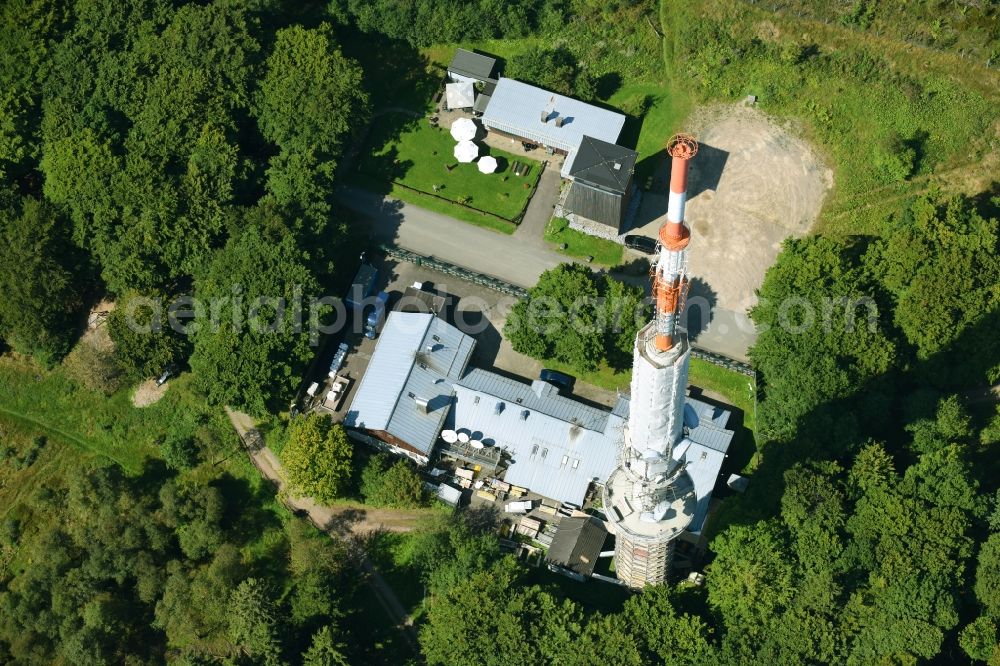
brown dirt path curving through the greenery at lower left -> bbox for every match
[226,407,426,652]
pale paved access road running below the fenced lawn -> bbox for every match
[338,183,756,360]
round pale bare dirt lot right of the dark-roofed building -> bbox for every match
[639,105,833,312]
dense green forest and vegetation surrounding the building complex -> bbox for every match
[0,0,1000,666]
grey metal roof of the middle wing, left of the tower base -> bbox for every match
[447,369,625,504]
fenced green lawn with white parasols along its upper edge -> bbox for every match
[358,113,542,226]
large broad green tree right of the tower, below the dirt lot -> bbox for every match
[749,236,897,438]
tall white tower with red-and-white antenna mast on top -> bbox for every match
[604,134,698,588]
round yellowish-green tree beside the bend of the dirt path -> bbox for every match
[281,413,354,502]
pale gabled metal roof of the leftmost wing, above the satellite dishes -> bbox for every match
[344,312,475,454]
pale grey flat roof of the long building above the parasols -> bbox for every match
[483,78,625,154]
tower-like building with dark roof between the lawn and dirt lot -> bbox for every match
[566,136,638,232]
